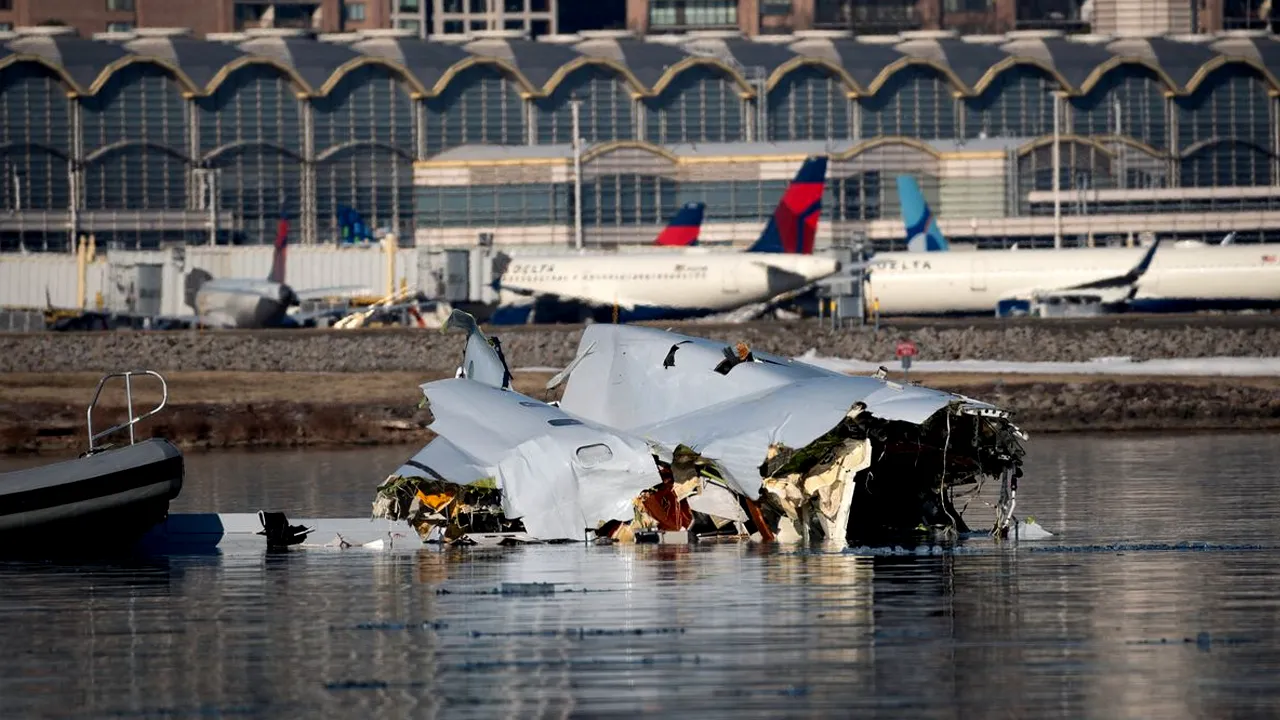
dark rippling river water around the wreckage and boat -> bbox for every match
[0,434,1280,719]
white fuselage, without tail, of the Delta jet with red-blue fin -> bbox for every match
[492,250,838,324]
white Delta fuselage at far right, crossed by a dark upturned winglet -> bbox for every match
[865,245,1280,315]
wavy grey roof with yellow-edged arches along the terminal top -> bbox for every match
[0,27,1280,96]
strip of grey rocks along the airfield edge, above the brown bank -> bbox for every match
[0,320,1280,373]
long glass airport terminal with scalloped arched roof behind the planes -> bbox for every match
[0,27,1280,251]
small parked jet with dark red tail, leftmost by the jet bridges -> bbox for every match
[182,214,369,328]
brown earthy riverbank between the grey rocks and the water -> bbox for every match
[0,370,1280,454]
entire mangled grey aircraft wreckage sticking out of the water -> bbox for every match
[374,310,1027,547]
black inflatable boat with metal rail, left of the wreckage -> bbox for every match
[0,370,184,556]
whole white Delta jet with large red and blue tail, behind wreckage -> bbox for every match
[489,156,840,324]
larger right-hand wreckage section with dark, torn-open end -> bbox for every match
[561,324,1025,542]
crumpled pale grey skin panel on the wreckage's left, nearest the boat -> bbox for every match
[375,379,662,541]
